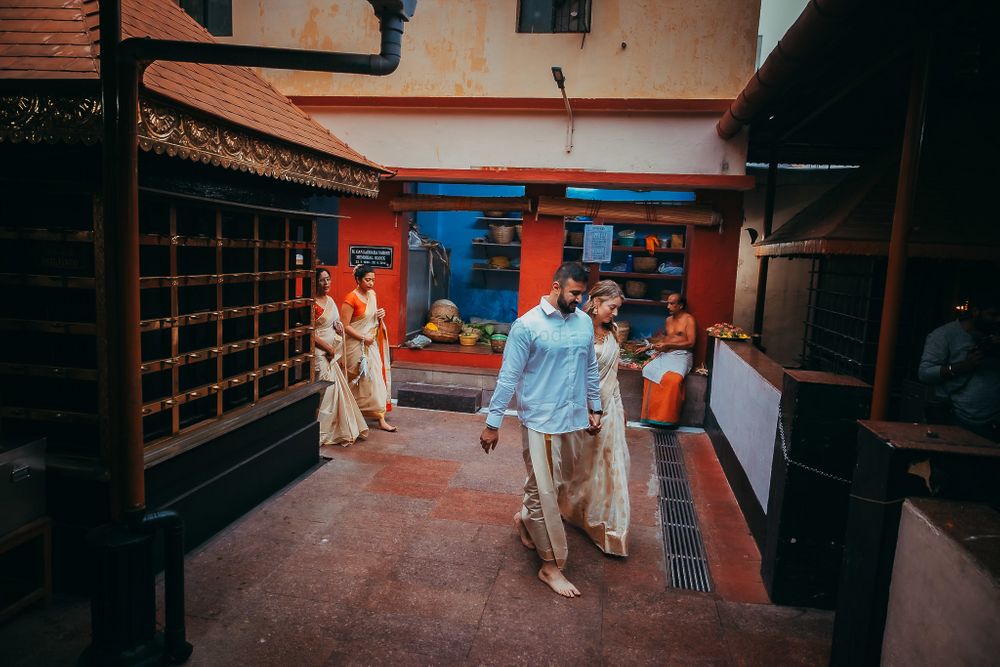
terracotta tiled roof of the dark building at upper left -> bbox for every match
[0,0,383,169]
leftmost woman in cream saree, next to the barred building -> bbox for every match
[313,269,368,447]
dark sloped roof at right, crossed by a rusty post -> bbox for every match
[754,160,1000,259]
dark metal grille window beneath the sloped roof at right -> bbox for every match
[802,256,885,382]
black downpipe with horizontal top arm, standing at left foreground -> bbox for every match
[81,0,417,665]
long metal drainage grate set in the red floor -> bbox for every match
[653,432,712,592]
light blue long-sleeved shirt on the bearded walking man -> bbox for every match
[486,297,601,435]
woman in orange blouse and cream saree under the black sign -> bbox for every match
[340,264,396,432]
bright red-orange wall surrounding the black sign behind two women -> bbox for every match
[329,183,408,345]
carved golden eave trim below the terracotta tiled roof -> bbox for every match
[0,95,381,198]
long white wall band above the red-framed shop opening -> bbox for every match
[304,107,746,175]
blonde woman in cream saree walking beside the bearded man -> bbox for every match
[552,280,630,556]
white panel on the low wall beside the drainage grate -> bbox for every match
[710,341,781,513]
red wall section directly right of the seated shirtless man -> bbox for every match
[685,190,743,364]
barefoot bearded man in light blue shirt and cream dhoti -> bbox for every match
[479,262,601,597]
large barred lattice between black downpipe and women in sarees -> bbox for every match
[139,193,316,445]
